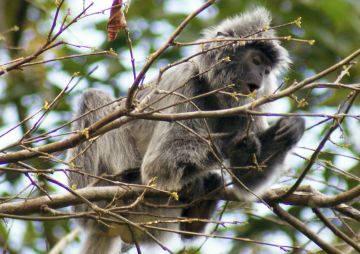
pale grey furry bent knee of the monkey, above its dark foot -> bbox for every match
[141,120,225,190]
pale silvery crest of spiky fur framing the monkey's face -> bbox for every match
[201,7,291,76]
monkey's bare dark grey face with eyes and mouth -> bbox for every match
[230,47,272,94]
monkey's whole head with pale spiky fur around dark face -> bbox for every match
[197,7,291,104]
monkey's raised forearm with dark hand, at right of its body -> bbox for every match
[229,117,305,197]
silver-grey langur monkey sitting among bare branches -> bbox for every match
[69,7,304,254]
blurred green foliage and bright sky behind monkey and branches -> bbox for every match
[0,0,360,254]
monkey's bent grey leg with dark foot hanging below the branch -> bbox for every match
[141,122,228,238]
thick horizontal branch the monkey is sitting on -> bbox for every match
[0,186,360,218]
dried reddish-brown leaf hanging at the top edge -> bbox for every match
[107,0,127,41]
